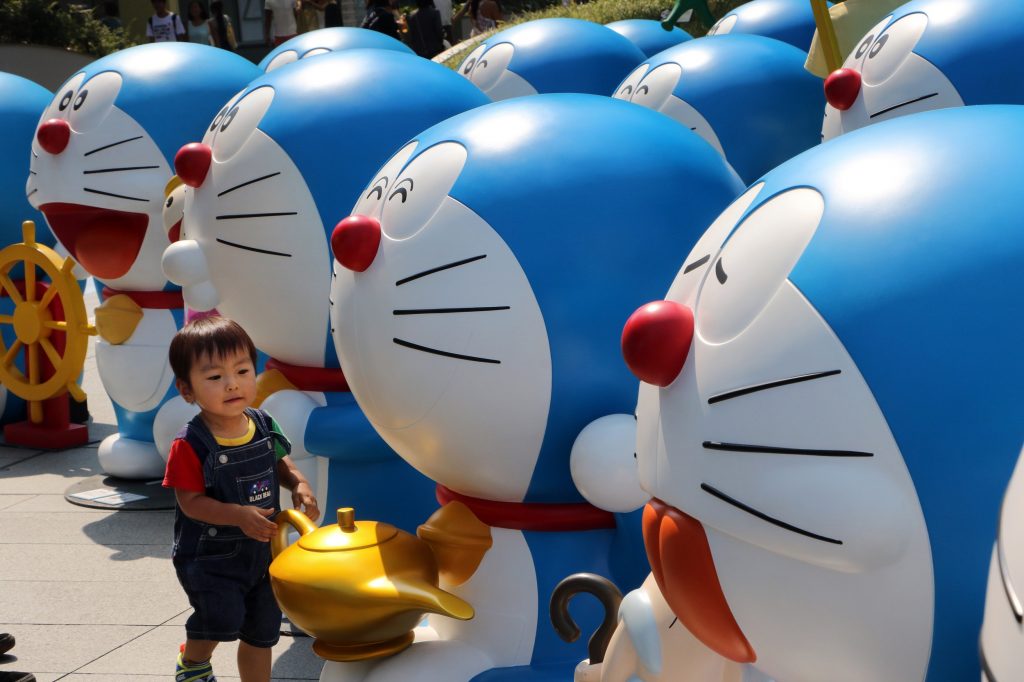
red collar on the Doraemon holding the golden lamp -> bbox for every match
[437,483,615,531]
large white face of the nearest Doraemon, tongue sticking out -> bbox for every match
[637,184,933,680]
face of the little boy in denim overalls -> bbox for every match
[177,350,256,418]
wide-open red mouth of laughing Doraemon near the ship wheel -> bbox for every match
[39,203,150,280]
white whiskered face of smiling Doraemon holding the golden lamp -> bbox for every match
[331,142,551,502]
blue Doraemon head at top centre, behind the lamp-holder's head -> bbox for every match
[458,18,644,101]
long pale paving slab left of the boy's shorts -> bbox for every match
[0,577,188,622]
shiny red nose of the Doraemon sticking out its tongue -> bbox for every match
[623,301,693,388]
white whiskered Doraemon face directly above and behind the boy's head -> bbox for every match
[164,87,331,367]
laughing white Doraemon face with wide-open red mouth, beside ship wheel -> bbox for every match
[27,72,173,291]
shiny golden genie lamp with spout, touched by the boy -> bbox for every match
[270,507,473,662]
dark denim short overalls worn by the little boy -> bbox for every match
[173,410,291,647]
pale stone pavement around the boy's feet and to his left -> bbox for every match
[0,282,323,682]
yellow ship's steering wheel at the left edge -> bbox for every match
[0,220,96,424]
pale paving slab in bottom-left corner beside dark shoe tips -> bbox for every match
[0,622,147,680]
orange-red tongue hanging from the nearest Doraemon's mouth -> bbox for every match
[643,499,757,663]
